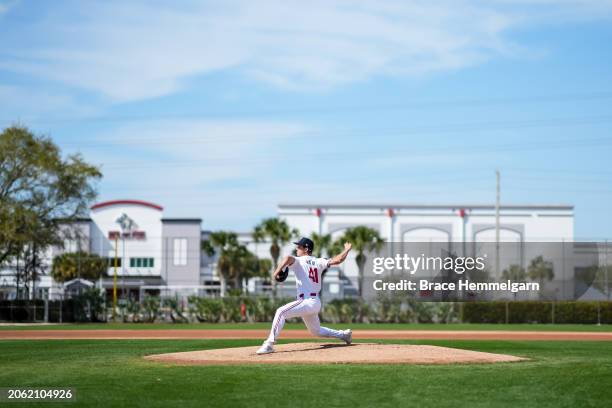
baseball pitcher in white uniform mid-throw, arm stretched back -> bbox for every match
[257,238,353,354]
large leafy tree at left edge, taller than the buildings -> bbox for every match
[0,126,102,270]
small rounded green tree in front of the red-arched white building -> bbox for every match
[51,252,108,283]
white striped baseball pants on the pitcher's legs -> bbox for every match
[266,297,342,344]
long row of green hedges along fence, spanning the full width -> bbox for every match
[0,291,612,324]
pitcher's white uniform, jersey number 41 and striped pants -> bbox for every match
[266,255,343,344]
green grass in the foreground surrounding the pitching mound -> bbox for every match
[0,340,612,408]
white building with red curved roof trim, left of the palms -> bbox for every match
[0,200,202,299]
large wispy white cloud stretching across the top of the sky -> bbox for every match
[0,0,612,102]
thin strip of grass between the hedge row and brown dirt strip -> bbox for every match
[0,320,612,332]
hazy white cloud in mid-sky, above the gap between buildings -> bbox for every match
[80,120,310,191]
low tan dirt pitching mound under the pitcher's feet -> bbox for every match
[145,343,526,365]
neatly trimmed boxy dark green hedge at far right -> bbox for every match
[463,301,612,324]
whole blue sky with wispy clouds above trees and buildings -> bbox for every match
[0,0,612,239]
